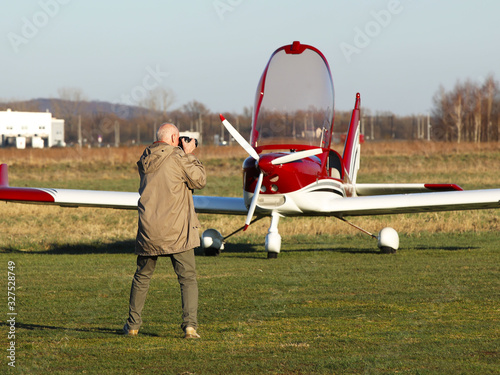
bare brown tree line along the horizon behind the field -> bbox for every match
[0,75,500,146]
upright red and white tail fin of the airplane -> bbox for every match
[342,93,361,195]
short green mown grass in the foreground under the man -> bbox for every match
[0,233,500,374]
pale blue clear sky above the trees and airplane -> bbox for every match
[0,0,500,115]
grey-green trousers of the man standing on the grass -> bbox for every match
[127,250,198,330]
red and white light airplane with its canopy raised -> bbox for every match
[0,42,500,258]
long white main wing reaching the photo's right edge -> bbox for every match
[329,189,500,217]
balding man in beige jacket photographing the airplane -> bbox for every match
[123,123,206,338]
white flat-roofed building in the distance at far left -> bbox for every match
[0,109,66,148]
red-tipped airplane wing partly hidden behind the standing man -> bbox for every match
[0,164,248,215]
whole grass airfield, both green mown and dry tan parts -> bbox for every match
[0,143,500,374]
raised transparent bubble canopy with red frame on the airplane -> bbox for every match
[250,42,334,148]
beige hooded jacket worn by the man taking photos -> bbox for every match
[135,142,206,256]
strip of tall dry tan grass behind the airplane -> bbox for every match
[0,142,500,247]
